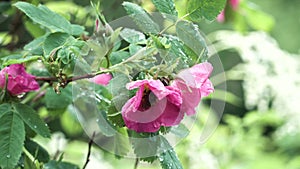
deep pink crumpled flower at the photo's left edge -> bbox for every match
[0,64,40,95]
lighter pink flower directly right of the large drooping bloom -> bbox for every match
[172,62,214,115]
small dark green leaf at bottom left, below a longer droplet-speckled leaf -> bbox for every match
[25,139,50,163]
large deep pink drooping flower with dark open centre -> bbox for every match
[122,80,184,132]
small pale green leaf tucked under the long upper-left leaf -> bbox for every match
[24,34,48,55]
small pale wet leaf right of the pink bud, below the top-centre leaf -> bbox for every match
[120,28,146,43]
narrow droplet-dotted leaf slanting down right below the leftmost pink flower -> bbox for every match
[13,103,51,138]
